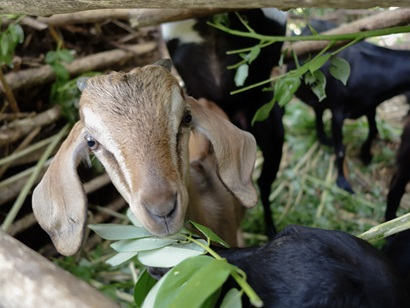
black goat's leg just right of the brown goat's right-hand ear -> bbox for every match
[252,106,284,239]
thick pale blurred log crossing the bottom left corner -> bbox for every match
[0,230,118,308]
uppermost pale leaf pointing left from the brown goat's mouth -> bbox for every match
[88,224,152,240]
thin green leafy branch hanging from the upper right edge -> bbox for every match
[209,13,410,124]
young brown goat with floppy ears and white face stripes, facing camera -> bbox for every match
[33,60,257,255]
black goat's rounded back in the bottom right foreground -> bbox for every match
[150,226,410,308]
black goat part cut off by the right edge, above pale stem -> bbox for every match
[385,117,410,220]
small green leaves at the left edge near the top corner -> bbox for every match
[0,17,24,67]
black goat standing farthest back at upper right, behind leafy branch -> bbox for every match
[288,21,410,192]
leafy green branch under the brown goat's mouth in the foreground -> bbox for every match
[89,210,262,307]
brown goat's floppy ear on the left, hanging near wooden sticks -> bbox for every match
[32,122,88,256]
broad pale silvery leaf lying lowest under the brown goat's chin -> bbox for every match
[138,240,206,267]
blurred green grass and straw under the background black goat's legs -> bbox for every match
[243,101,401,248]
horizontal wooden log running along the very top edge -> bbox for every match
[0,0,409,16]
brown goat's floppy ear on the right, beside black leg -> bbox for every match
[187,97,258,207]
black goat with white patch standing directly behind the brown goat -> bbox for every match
[162,8,286,237]
